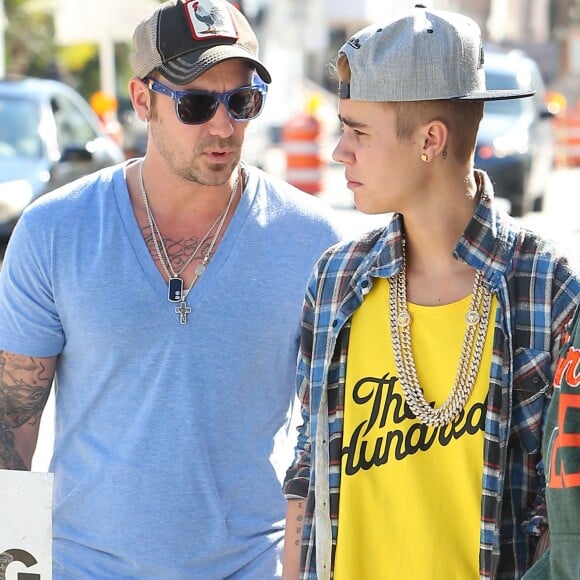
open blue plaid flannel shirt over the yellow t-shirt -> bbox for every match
[284,173,580,580]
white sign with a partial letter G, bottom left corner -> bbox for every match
[0,469,54,580]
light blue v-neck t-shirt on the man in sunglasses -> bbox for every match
[0,164,339,580]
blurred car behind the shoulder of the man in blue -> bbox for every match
[0,78,124,239]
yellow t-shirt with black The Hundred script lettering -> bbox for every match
[334,279,497,580]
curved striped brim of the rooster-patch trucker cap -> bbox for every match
[157,45,272,85]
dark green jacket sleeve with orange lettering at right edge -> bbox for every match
[524,309,580,580]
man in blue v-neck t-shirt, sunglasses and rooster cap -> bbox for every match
[0,0,338,580]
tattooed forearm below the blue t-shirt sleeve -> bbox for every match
[0,351,54,469]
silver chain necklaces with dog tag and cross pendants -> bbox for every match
[139,161,240,324]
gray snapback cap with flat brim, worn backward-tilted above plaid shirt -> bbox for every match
[339,4,534,102]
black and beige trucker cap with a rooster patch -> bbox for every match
[130,0,272,85]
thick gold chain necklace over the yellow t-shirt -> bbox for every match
[389,242,491,427]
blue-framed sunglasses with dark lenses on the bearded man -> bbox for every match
[144,76,268,125]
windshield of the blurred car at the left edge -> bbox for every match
[0,95,42,158]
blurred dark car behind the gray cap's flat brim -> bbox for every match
[475,50,555,217]
